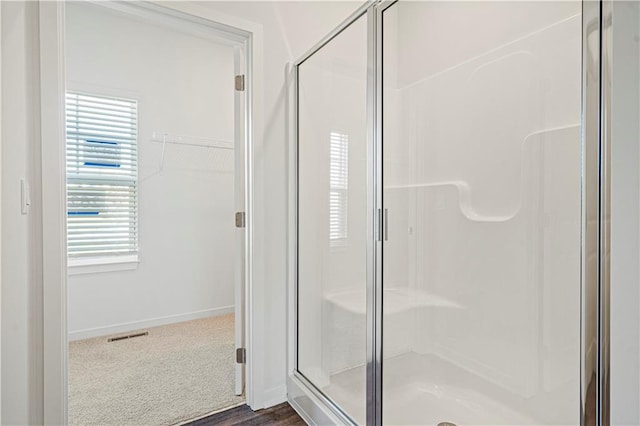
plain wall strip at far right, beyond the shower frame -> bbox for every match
[611,1,640,426]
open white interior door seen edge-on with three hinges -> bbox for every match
[234,47,247,395]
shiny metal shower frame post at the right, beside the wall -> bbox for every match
[580,0,613,426]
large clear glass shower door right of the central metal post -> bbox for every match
[380,1,582,425]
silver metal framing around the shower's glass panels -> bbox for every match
[287,0,613,426]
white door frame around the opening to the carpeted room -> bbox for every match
[35,0,265,424]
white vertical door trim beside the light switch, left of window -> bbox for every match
[39,1,67,424]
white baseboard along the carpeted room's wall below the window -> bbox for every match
[69,306,234,342]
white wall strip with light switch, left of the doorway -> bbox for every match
[0,2,43,424]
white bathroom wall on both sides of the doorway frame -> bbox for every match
[1,2,359,424]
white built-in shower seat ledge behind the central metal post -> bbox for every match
[325,287,462,315]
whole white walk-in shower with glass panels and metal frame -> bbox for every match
[289,0,610,425]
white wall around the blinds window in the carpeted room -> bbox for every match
[66,3,235,338]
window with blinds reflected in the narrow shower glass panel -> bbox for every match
[329,132,349,247]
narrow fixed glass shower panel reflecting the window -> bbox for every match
[297,12,367,424]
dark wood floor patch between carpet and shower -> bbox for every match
[185,402,306,426]
